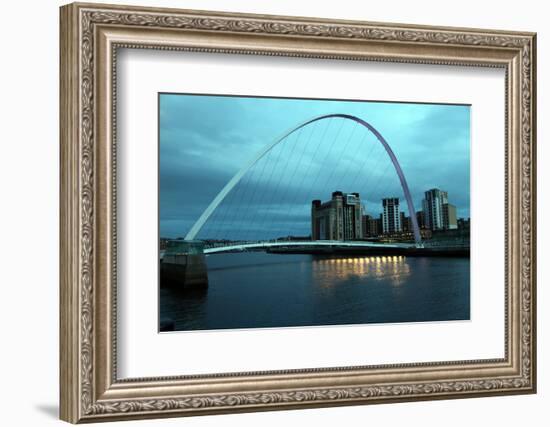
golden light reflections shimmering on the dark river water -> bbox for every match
[311,255,411,288]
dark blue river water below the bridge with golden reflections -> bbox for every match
[160,252,470,330]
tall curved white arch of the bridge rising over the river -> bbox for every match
[185,113,422,245]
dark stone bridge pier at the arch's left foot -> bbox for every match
[160,240,208,289]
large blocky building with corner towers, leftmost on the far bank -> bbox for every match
[311,191,363,240]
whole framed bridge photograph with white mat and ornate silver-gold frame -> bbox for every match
[60,4,536,423]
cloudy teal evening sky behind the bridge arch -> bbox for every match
[159,94,470,239]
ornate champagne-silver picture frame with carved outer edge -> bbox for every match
[60,3,536,423]
